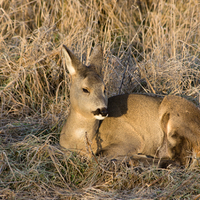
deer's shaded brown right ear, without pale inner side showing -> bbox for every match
[90,44,103,75]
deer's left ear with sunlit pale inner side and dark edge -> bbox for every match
[62,45,81,76]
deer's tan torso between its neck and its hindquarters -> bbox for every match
[97,94,163,157]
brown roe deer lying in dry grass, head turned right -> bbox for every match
[60,45,200,164]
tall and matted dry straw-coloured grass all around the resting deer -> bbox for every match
[0,0,200,199]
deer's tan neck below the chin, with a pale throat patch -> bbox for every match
[66,108,99,141]
